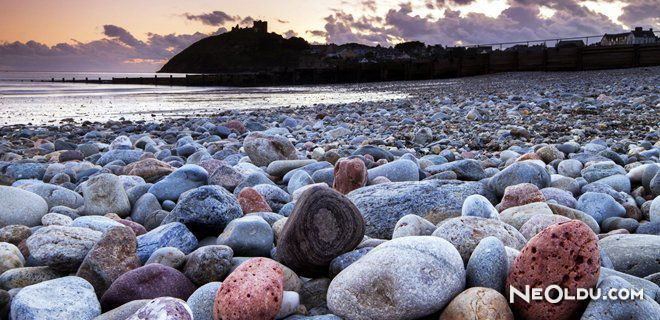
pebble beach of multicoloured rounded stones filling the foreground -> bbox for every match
[0,67,660,320]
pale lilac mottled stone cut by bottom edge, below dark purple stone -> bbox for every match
[126,297,193,320]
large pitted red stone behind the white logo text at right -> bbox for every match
[505,220,600,320]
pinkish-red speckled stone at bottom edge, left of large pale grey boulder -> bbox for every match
[213,258,284,320]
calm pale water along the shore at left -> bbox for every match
[0,72,406,125]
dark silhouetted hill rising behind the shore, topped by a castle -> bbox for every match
[159,28,310,73]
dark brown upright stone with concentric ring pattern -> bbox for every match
[277,187,364,277]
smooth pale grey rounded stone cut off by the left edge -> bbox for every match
[0,186,48,227]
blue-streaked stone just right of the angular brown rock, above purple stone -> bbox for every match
[137,222,197,262]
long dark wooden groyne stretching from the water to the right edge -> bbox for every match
[40,43,660,87]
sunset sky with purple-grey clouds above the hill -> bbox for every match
[0,0,660,72]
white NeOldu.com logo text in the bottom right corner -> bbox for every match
[509,285,644,304]
